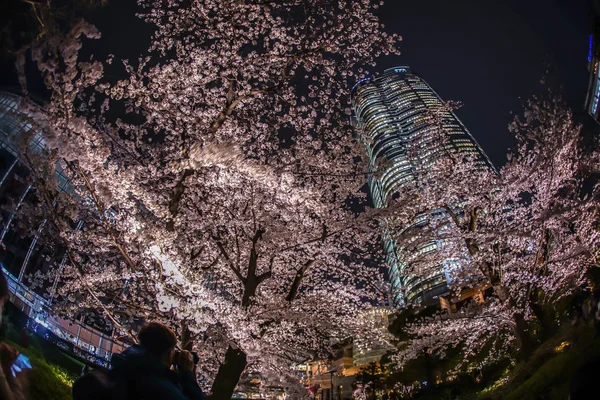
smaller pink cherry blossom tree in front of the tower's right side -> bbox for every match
[390,94,599,370]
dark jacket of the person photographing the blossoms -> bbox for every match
[111,345,204,400]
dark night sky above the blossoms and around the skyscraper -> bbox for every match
[0,0,591,166]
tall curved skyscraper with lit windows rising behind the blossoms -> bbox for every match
[352,66,491,306]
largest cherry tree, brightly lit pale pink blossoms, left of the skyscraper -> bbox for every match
[11,0,399,398]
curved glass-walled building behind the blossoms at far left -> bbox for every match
[0,92,124,366]
